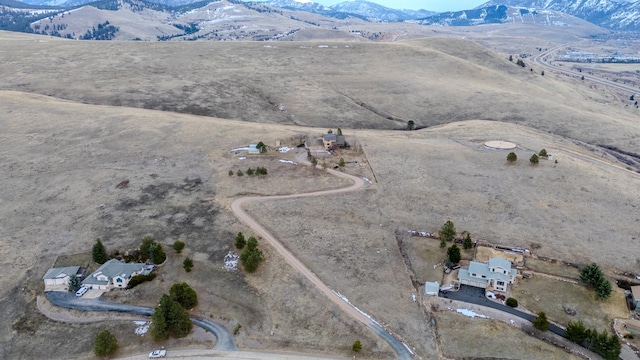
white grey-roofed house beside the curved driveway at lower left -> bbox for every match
[82,259,146,290]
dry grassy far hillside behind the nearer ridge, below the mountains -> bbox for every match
[0,33,640,153]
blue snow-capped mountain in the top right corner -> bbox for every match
[480,0,640,31]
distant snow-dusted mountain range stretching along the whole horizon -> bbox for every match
[0,0,640,34]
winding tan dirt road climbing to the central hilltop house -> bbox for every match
[231,158,412,359]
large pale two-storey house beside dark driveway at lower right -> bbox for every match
[458,258,518,292]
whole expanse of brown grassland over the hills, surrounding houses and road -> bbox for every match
[0,26,640,358]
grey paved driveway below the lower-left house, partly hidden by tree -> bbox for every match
[45,291,238,351]
